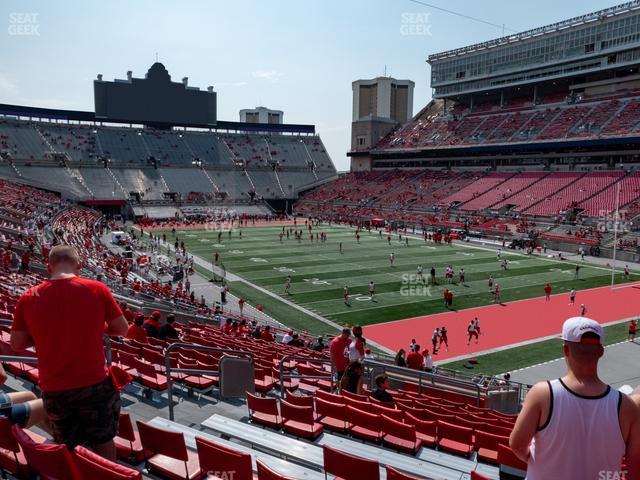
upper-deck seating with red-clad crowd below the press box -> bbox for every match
[374,91,639,151]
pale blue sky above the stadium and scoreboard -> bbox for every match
[0,0,615,170]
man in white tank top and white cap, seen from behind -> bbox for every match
[509,317,640,480]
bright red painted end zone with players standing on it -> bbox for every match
[364,284,640,361]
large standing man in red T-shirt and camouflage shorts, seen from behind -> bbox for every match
[11,245,128,460]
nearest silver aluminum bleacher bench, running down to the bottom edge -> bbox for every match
[148,417,325,480]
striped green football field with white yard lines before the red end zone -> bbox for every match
[152,225,633,331]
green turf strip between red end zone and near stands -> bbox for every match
[442,322,628,375]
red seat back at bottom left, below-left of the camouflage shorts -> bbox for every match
[11,425,81,480]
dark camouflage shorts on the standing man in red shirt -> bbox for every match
[42,377,120,449]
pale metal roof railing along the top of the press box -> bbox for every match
[427,0,640,63]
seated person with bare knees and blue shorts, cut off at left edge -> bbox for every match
[0,363,51,432]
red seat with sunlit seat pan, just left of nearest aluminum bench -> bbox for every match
[136,421,200,480]
